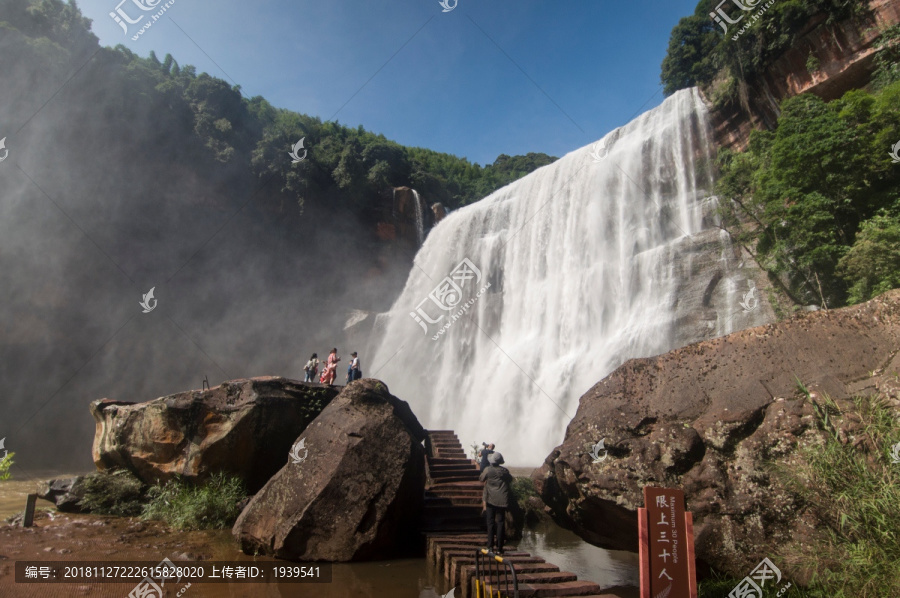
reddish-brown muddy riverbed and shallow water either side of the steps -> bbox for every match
[0,476,637,598]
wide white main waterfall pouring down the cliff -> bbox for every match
[370,89,764,465]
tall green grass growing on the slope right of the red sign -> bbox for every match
[782,385,900,598]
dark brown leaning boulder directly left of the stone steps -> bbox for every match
[233,379,425,561]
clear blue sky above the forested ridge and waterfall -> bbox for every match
[79,0,697,164]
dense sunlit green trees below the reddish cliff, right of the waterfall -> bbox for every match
[717,83,900,307]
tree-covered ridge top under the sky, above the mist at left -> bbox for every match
[0,0,555,220]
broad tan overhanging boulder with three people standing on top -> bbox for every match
[91,377,338,493]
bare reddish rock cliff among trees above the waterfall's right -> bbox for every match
[712,0,900,150]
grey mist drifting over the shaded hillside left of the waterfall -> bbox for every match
[0,32,411,478]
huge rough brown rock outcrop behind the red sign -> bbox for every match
[535,290,900,577]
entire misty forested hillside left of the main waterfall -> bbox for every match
[0,0,553,467]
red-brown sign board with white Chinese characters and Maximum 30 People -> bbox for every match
[638,486,697,598]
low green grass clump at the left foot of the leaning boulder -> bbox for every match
[142,472,247,530]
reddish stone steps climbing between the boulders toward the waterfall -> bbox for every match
[421,430,638,598]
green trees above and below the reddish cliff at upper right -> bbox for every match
[662,0,900,308]
